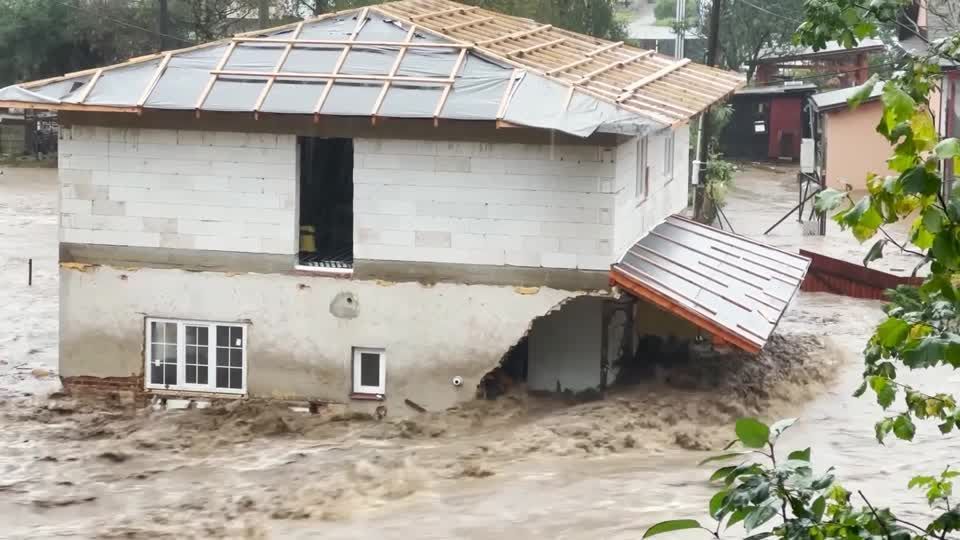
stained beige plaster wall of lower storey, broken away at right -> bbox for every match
[60,266,584,414]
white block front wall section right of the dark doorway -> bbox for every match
[354,139,615,269]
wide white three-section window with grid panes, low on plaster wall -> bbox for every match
[144,317,247,394]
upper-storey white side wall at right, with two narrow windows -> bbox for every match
[614,125,690,259]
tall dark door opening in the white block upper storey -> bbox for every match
[298,137,353,269]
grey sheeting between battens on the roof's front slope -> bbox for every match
[0,11,666,137]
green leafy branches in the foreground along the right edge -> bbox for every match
[647,0,960,540]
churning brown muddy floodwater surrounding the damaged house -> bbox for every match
[0,168,960,540]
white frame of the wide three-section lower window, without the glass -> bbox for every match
[143,317,249,395]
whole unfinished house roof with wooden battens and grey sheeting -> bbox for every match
[0,0,742,137]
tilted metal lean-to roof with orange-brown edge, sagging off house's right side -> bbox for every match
[611,216,810,353]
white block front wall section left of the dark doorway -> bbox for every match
[60,126,297,254]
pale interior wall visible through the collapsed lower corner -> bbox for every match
[527,297,606,392]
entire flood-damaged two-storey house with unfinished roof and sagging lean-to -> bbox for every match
[0,0,805,414]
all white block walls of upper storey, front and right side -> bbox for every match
[60,126,689,270]
